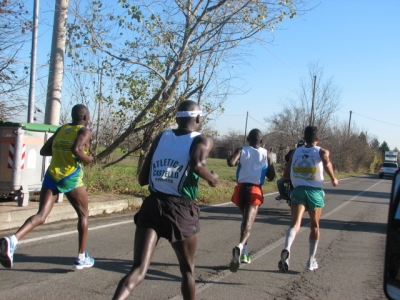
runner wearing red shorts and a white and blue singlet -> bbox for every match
[227,129,275,272]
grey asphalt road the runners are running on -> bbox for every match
[0,176,391,300]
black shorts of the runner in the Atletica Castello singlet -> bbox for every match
[133,193,200,243]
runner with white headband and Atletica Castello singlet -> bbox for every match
[113,100,218,300]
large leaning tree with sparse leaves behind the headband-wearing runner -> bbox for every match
[63,0,305,171]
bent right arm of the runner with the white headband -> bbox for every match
[189,135,218,187]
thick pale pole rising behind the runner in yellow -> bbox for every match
[44,0,69,125]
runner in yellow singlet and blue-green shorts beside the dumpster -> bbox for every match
[0,104,94,270]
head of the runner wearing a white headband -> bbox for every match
[176,100,203,131]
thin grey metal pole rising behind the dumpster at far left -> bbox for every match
[27,0,39,123]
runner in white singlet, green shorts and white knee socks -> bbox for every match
[278,126,338,272]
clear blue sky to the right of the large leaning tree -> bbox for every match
[216,0,400,149]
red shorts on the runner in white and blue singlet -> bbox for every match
[232,183,264,206]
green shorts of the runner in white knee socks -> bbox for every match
[291,186,325,210]
